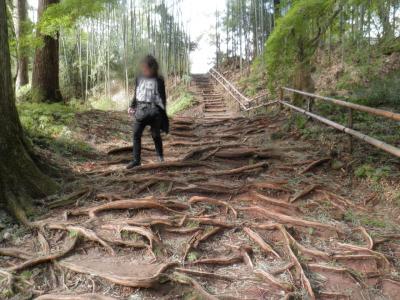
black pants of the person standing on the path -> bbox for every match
[133,108,163,162]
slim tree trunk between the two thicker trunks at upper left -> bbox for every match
[14,0,29,89]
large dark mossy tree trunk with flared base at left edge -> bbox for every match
[0,0,57,222]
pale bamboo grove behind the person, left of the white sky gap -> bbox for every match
[67,0,190,100]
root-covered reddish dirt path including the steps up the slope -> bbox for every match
[0,76,400,300]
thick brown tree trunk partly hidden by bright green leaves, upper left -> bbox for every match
[32,0,62,102]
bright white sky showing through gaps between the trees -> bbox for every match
[28,0,226,73]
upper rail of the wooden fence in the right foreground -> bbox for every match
[283,87,400,121]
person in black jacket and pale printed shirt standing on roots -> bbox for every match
[126,55,169,169]
